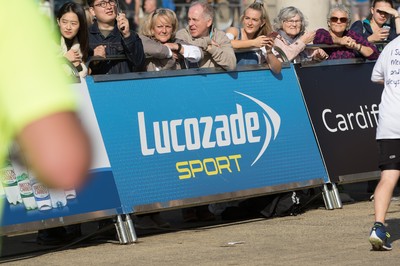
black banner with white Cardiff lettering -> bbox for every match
[295,62,383,182]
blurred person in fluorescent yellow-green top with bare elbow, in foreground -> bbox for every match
[0,1,91,193]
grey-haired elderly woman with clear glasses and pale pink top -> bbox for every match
[273,6,328,62]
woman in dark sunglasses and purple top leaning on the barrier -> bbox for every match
[314,5,379,60]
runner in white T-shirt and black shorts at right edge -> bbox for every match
[369,34,400,250]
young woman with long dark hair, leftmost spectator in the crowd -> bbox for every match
[57,2,89,77]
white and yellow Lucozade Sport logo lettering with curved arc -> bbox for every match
[137,92,281,179]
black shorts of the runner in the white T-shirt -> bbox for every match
[378,139,400,171]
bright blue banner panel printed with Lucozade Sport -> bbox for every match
[87,65,327,213]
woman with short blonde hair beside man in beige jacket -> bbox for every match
[139,8,203,71]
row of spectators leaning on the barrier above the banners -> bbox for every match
[33,0,400,246]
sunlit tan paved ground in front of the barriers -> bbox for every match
[0,183,400,266]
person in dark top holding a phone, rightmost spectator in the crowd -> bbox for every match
[350,0,400,42]
